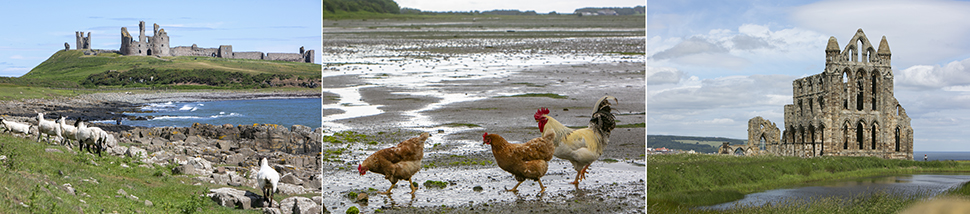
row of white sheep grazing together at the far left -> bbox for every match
[0,113,115,156]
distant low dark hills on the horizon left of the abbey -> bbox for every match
[647,135,747,153]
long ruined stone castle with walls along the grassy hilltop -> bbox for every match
[72,21,314,63]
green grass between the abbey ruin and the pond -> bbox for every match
[647,154,970,213]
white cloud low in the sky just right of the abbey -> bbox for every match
[893,59,970,91]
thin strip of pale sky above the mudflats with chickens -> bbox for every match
[395,0,644,13]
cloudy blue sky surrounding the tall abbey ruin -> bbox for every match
[646,0,970,151]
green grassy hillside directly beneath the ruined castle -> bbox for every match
[15,50,321,87]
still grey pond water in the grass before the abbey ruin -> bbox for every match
[698,174,970,210]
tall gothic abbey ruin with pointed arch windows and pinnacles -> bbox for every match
[722,29,913,160]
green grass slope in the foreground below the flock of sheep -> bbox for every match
[0,134,258,213]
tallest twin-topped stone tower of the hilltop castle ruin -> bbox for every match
[119,21,171,56]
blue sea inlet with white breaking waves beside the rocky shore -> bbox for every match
[102,98,321,128]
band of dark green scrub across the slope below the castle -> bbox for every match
[81,68,317,88]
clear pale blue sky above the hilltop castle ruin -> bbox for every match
[0,0,323,77]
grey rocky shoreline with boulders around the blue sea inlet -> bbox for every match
[0,91,326,212]
